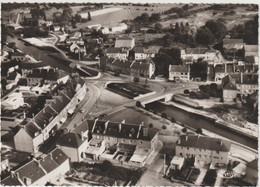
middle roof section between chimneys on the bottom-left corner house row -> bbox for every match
[15,160,45,183]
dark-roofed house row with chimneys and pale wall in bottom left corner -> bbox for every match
[1,148,70,186]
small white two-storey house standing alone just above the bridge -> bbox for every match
[169,65,190,82]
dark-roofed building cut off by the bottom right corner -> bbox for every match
[243,159,258,186]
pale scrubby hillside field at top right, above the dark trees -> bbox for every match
[161,7,257,30]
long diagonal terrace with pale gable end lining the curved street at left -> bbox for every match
[14,77,86,153]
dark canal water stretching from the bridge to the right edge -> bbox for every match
[148,102,258,149]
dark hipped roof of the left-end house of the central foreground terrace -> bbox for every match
[58,132,84,148]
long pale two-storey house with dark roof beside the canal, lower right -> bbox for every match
[175,135,231,165]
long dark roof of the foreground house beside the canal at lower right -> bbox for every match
[179,135,231,152]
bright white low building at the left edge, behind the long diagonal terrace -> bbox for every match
[1,92,24,110]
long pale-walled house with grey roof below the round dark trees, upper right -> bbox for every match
[181,47,217,64]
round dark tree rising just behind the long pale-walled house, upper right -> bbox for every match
[196,28,215,46]
